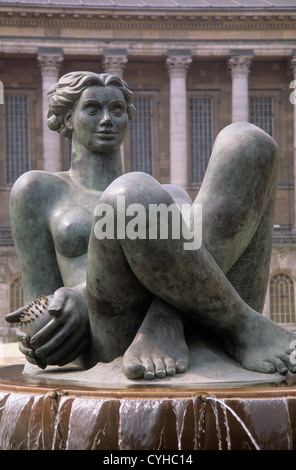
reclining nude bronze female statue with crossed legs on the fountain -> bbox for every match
[6,72,296,379]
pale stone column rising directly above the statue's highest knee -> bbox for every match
[229,50,253,122]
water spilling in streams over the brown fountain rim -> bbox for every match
[0,376,296,450]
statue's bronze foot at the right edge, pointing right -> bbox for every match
[226,311,296,375]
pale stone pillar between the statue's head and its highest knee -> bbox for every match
[167,49,192,190]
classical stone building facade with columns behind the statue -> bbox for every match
[0,0,296,328]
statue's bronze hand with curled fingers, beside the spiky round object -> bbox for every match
[28,287,89,367]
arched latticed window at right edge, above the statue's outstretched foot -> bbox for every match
[269,273,296,324]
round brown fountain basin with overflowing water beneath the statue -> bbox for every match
[0,364,296,450]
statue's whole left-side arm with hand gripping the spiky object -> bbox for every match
[6,172,89,367]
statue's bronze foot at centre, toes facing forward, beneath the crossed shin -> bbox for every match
[122,302,189,380]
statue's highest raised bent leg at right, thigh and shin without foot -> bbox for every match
[195,123,278,312]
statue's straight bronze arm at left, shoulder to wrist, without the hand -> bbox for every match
[9,171,63,303]
